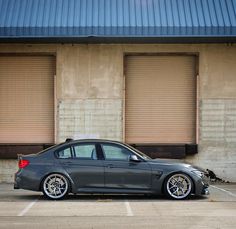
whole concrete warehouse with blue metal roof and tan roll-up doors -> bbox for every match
[0,0,236,182]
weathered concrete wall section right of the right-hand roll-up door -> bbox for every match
[190,45,236,182]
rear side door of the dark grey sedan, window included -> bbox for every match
[58,143,104,191]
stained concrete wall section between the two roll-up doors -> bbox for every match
[57,45,123,141]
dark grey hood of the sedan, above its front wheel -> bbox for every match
[148,158,205,172]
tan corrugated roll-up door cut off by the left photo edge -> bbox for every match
[0,55,55,143]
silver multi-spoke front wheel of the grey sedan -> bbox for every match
[166,173,192,199]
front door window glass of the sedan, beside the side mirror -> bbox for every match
[102,144,131,161]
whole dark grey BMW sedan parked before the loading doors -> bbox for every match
[14,139,208,200]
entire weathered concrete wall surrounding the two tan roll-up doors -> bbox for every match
[0,44,236,181]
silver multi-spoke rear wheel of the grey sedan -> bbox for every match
[43,173,69,199]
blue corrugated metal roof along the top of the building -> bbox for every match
[0,0,236,42]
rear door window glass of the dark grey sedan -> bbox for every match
[74,144,97,160]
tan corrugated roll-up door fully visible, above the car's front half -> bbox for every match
[125,56,196,143]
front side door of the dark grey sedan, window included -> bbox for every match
[101,143,151,190]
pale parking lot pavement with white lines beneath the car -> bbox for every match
[0,184,236,229]
